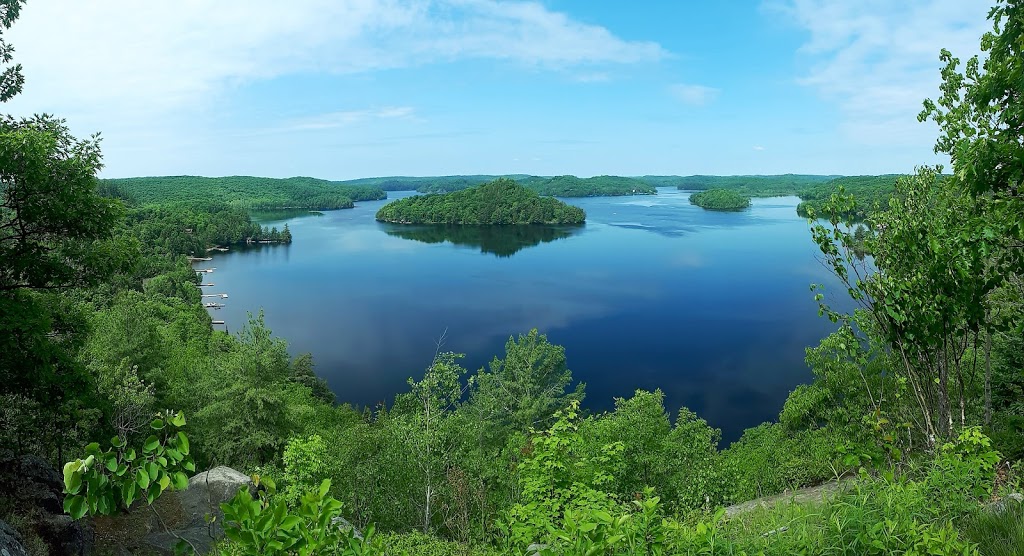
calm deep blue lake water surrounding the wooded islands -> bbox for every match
[201,188,843,441]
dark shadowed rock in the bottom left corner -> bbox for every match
[0,456,94,556]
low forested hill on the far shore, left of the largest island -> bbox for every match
[100,176,387,210]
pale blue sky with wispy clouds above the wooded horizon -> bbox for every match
[0,0,991,179]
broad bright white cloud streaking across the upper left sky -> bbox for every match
[7,0,667,122]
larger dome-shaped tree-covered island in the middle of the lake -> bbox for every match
[377,178,587,225]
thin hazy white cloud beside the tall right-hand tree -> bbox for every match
[766,0,991,145]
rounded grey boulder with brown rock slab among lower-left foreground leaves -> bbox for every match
[95,467,254,554]
